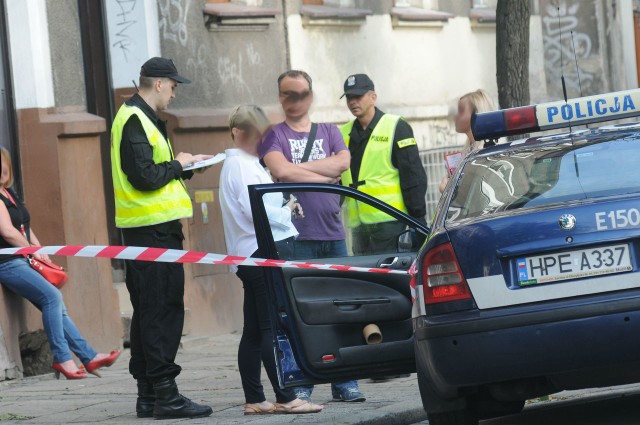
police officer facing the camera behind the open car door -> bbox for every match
[340,74,427,255]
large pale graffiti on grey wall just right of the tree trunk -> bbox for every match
[542,0,601,97]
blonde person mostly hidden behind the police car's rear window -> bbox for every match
[440,89,494,193]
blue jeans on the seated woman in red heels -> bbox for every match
[0,258,97,364]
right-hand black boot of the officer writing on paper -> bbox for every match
[153,378,213,419]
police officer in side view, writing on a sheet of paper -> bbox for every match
[111,57,212,419]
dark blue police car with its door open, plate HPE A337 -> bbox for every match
[250,90,640,425]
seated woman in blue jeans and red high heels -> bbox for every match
[0,148,120,379]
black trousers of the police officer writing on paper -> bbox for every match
[122,220,184,381]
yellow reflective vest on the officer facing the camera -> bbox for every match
[340,114,407,227]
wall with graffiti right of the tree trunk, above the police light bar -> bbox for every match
[539,0,638,100]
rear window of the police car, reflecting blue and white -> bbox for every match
[447,133,640,222]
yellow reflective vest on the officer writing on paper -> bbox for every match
[111,104,193,227]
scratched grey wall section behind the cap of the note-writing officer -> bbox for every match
[158,0,286,108]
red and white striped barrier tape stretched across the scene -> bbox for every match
[0,245,408,274]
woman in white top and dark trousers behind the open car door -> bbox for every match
[220,105,322,415]
